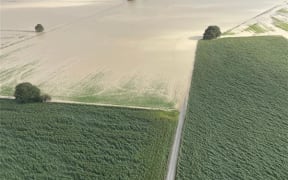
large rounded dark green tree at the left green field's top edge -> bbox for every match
[14,82,41,103]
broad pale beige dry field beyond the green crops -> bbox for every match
[0,0,281,108]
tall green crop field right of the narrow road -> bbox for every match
[177,37,288,180]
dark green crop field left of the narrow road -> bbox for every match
[0,99,178,180]
